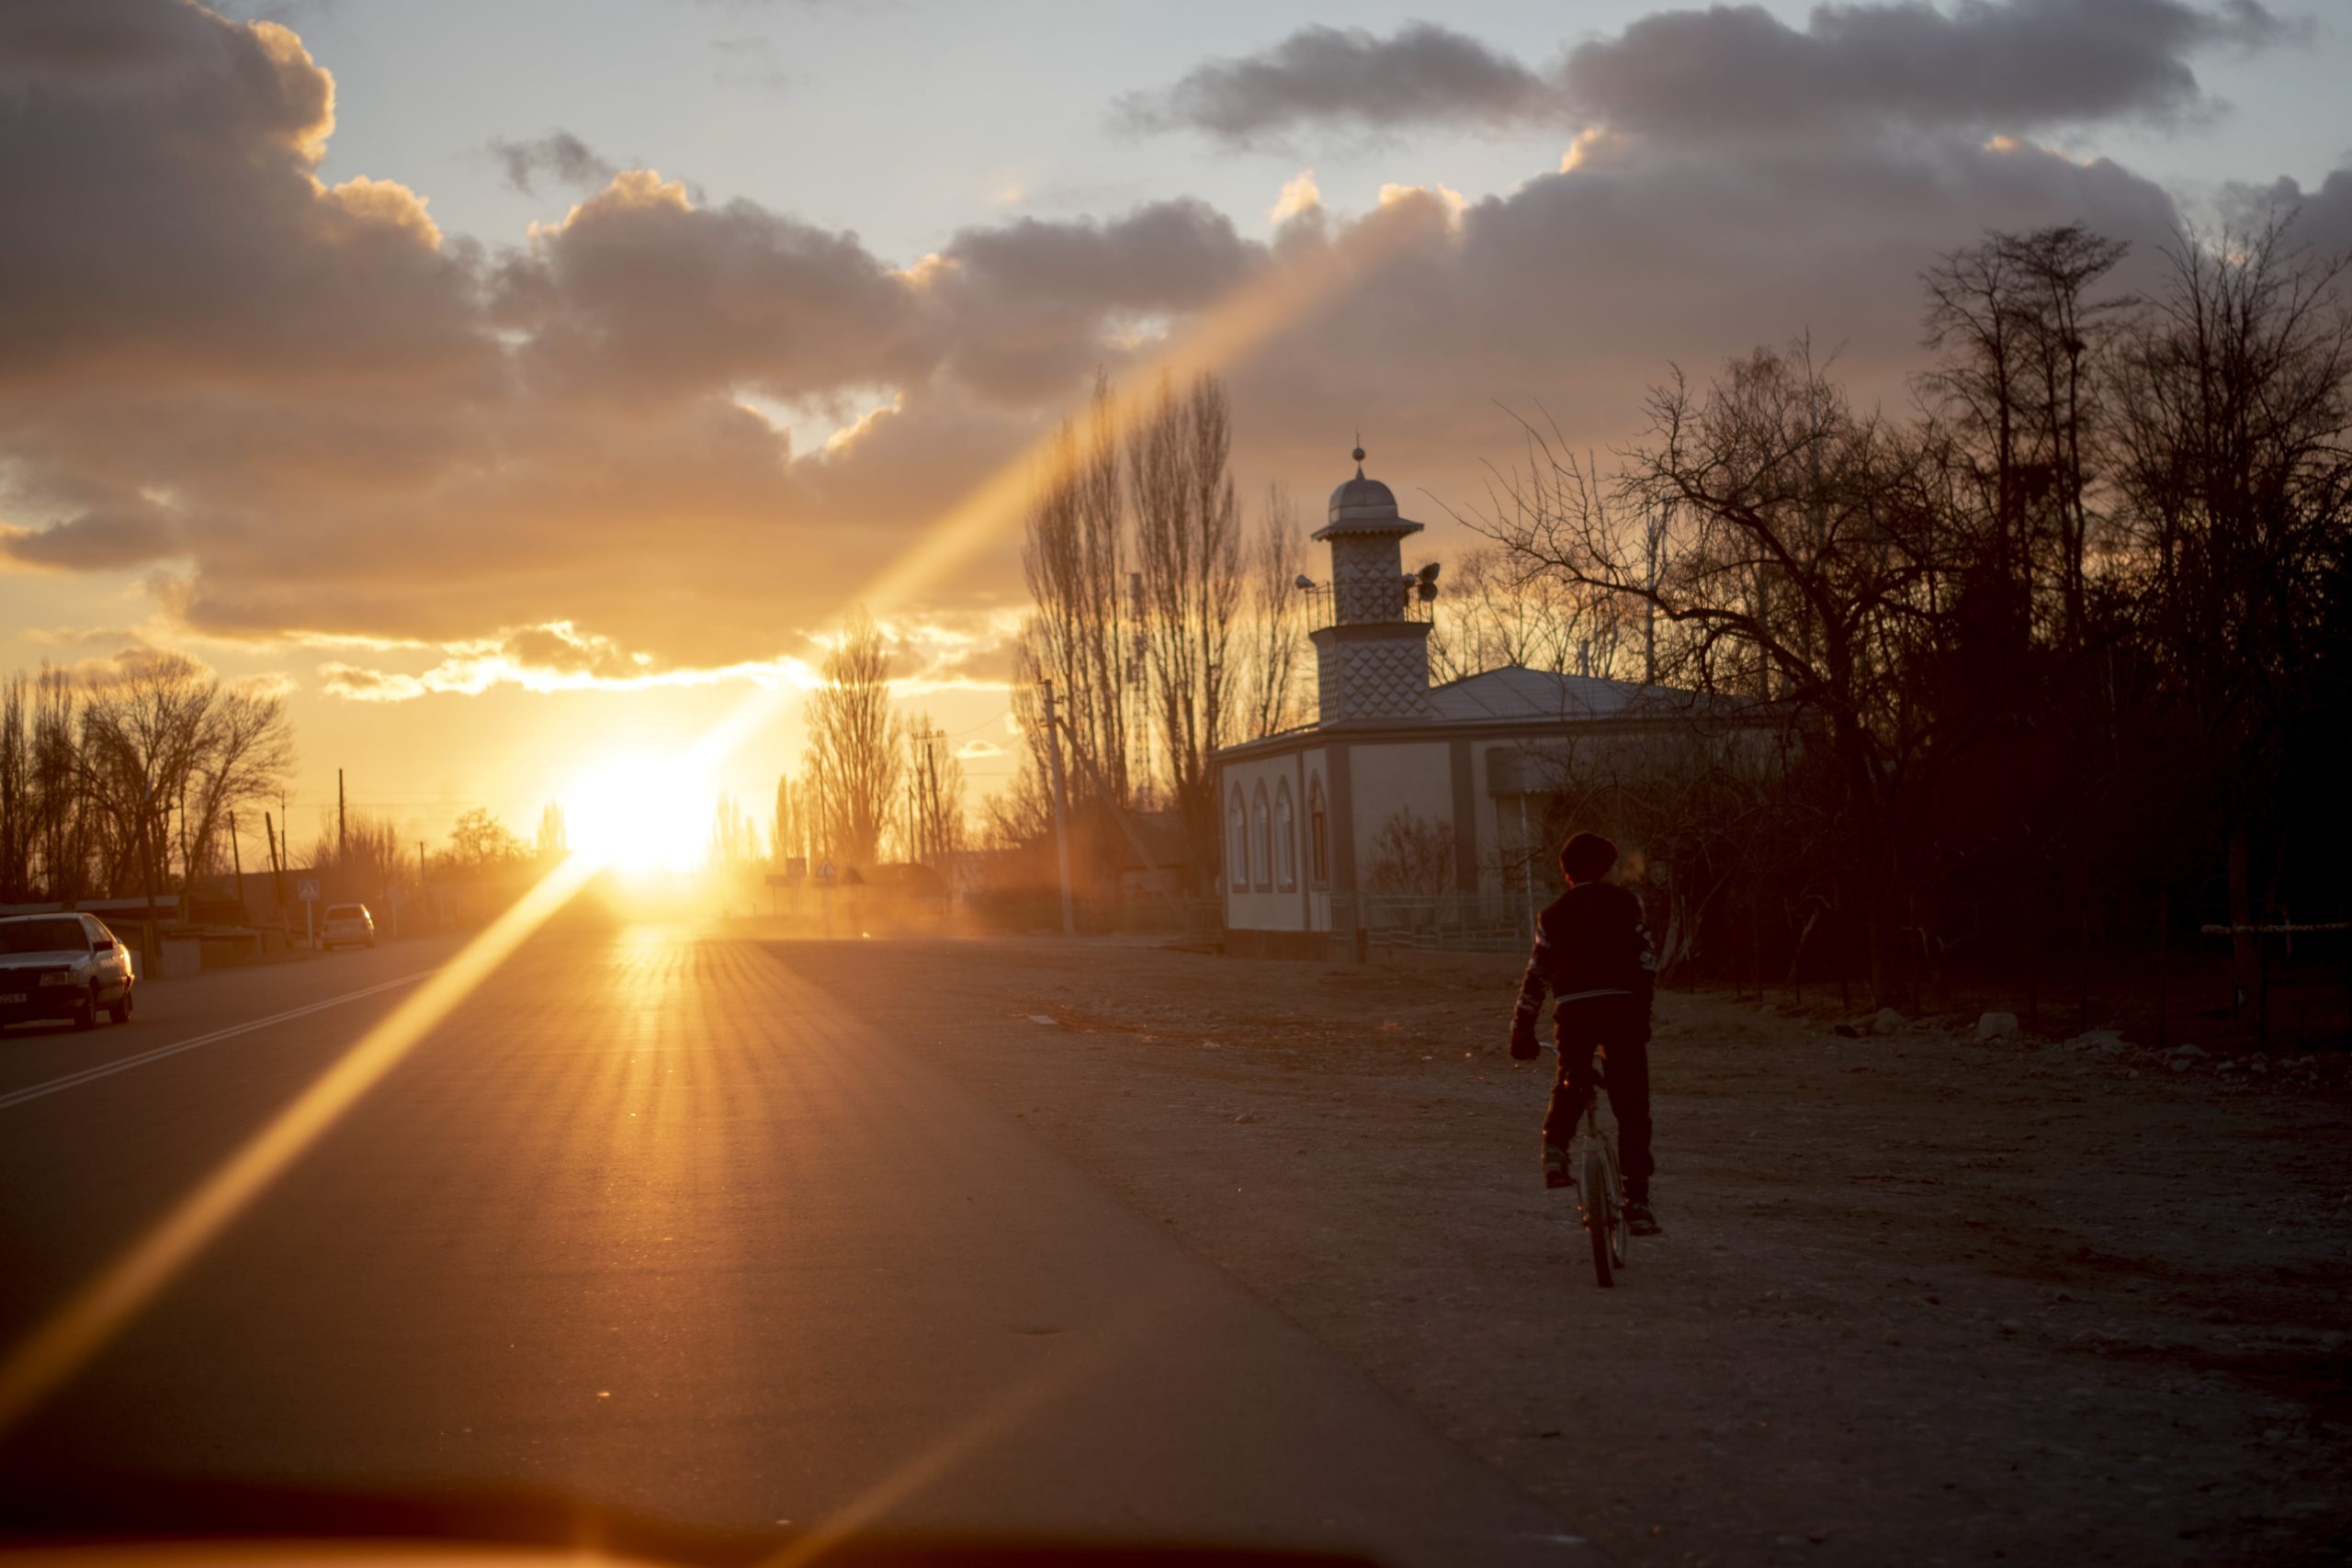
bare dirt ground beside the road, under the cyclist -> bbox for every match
[781,941,2352,1563]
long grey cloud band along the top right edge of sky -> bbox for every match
[1113,0,2298,146]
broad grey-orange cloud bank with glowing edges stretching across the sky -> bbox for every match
[0,0,2314,701]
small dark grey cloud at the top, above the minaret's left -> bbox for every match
[1114,21,1557,146]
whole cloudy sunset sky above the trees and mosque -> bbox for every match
[0,0,2352,860]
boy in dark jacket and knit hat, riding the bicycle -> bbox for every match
[1510,832,1658,1236]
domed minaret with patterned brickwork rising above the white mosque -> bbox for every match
[1312,446,1430,724]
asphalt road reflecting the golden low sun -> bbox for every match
[0,926,1595,1563]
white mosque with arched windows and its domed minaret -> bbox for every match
[1216,451,1689,957]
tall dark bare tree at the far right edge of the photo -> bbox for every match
[2109,216,2352,983]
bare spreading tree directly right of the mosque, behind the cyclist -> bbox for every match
[1484,341,1933,995]
